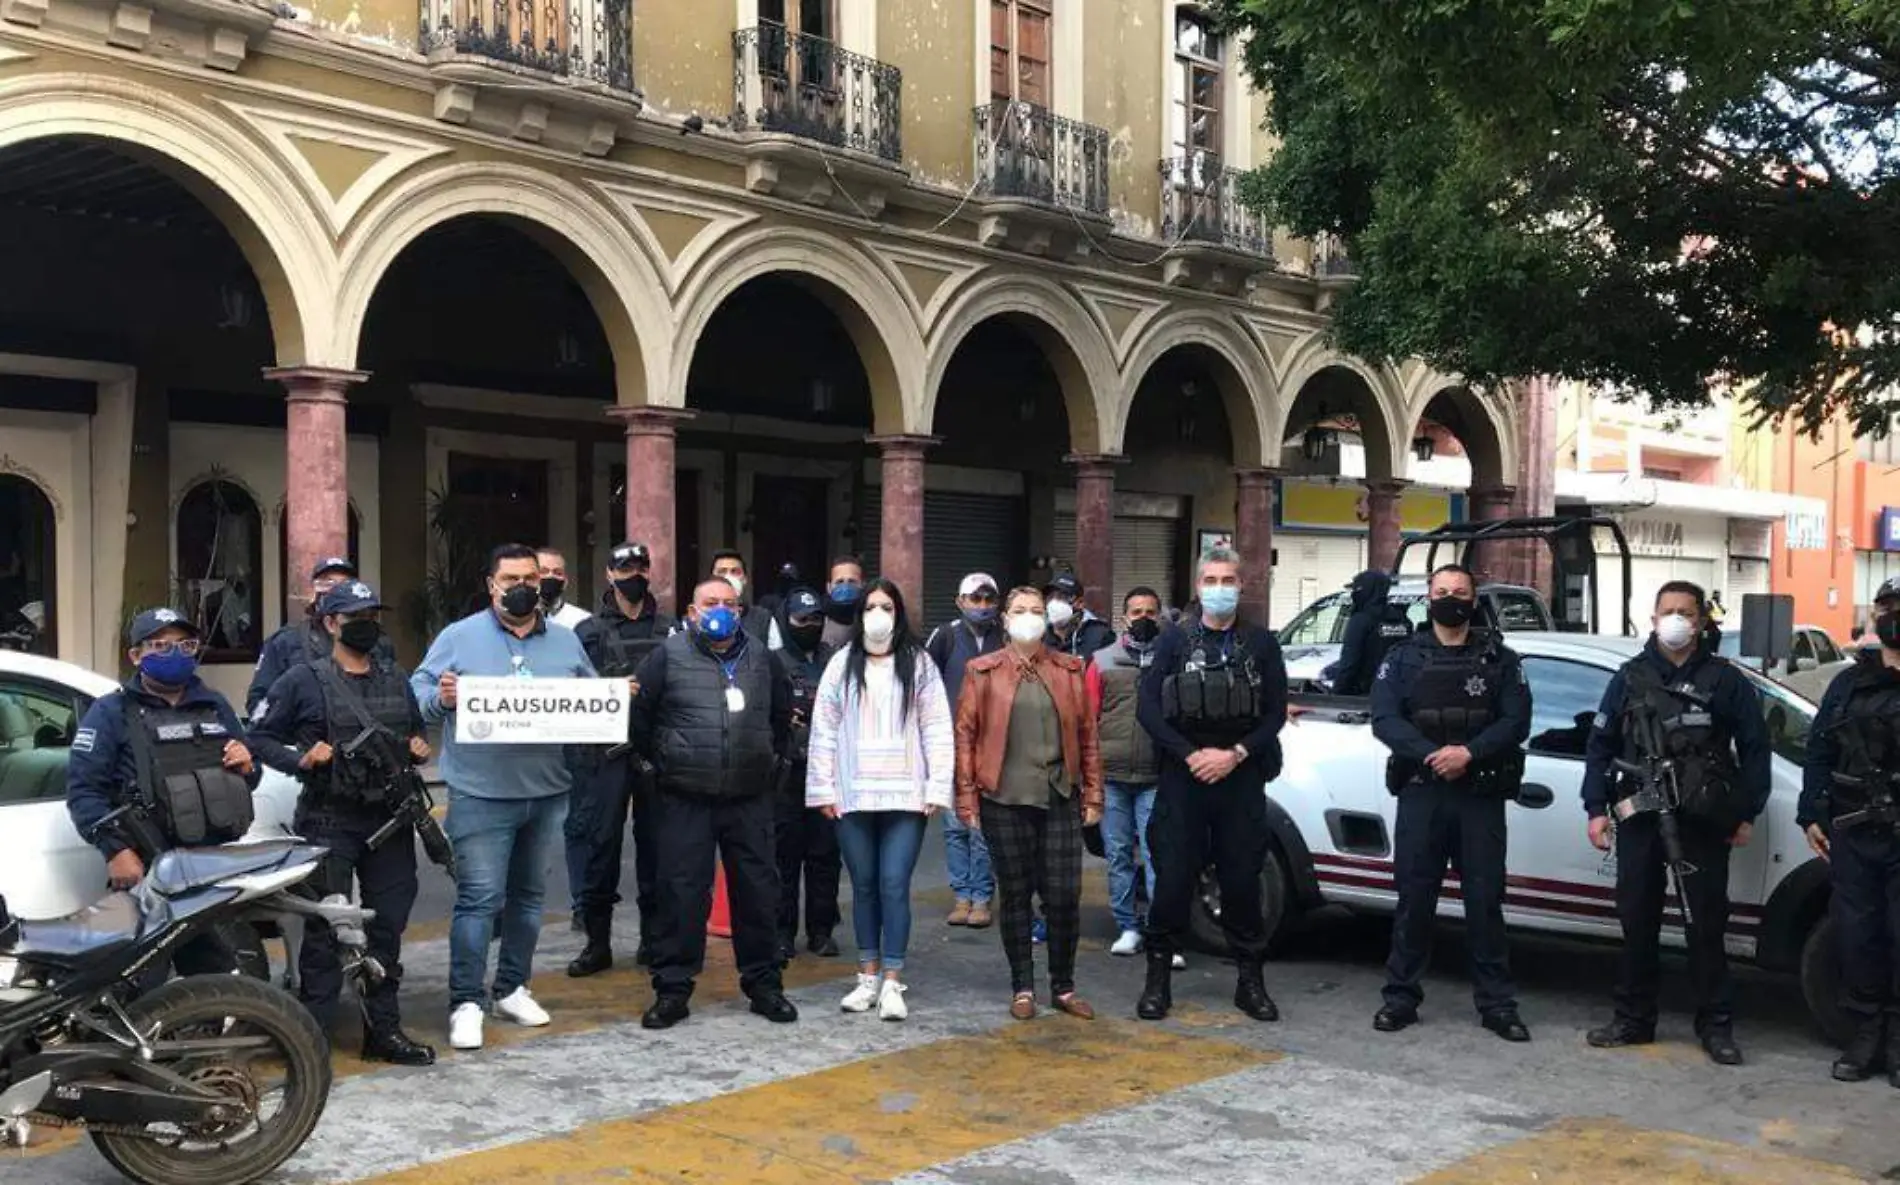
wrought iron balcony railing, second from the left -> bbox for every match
[732,23,904,161]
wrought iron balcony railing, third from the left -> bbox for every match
[975,99,1108,215]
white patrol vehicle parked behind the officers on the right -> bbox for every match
[1193,632,1843,1035]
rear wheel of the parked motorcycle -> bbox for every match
[91,974,331,1185]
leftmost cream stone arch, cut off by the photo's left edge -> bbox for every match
[0,74,342,367]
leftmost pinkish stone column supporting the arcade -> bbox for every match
[264,367,369,621]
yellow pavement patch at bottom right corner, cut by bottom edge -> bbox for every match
[1419,1119,1866,1185]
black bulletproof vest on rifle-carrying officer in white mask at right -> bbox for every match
[1621,655,1740,824]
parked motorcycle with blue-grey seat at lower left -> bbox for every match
[0,811,384,1185]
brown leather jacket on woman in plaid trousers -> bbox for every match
[956,646,1102,822]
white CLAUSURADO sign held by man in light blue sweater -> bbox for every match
[456,674,633,744]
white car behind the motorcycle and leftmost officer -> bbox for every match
[0,649,298,919]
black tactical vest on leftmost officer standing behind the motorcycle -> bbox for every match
[125,695,257,847]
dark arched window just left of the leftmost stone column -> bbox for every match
[177,479,264,663]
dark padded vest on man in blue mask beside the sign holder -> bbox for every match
[654,634,777,798]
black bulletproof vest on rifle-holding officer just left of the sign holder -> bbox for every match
[315,659,414,805]
